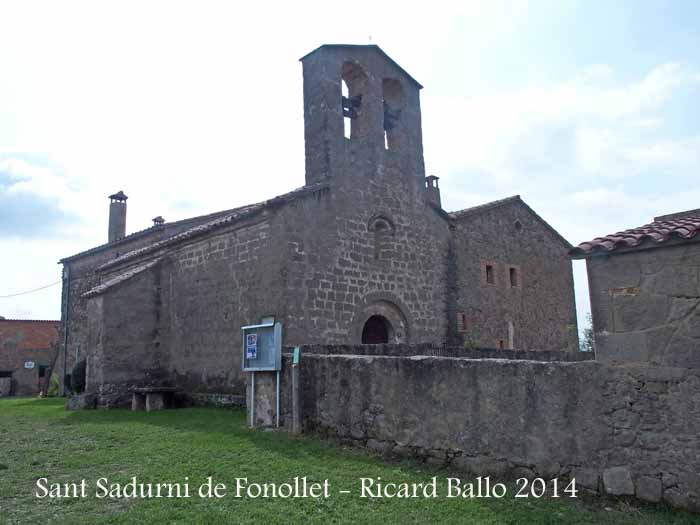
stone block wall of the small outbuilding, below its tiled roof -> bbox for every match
[586,242,700,368]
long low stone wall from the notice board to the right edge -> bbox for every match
[255,353,700,511]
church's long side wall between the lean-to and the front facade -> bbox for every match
[163,211,285,394]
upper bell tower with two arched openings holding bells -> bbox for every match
[301,45,425,192]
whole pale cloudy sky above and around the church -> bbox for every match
[0,0,700,336]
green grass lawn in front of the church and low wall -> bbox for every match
[0,398,700,525]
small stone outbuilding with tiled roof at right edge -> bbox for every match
[572,209,700,368]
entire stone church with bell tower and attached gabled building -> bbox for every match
[61,45,577,406]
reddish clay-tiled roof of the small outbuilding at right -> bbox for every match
[570,210,700,259]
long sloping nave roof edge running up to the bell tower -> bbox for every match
[98,182,328,271]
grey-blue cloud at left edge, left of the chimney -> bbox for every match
[0,155,80,239]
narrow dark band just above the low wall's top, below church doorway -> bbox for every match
[285,343,595,362]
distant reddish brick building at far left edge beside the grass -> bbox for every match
[0,319,60,397]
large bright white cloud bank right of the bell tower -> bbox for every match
[423,62,700,334]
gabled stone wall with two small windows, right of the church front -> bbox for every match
[454,199,578,351]
